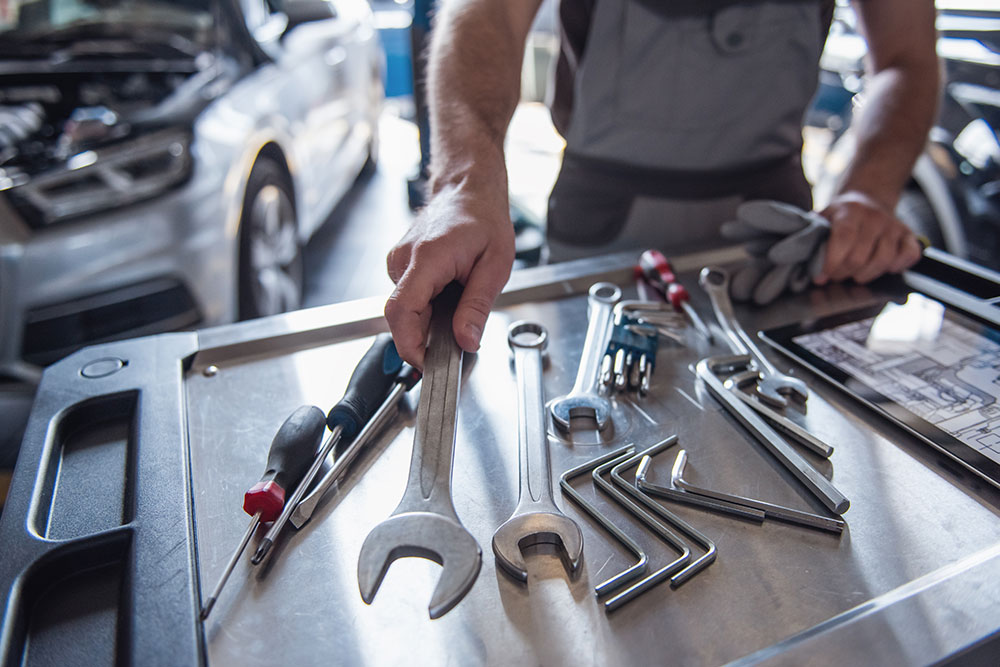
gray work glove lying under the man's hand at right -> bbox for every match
[722,200,830,305]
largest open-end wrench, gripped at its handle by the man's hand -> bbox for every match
[358,283,482,618]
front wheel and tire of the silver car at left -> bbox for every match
[239,158,303,320]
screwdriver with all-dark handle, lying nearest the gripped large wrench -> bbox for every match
[250,333,403,565]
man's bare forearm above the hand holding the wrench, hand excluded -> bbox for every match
[427,0,538,210]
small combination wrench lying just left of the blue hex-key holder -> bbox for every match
[551,283,622,431]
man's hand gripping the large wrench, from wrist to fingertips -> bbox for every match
[385,186,514,369]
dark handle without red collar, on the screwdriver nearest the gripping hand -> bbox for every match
[326,333,403,441]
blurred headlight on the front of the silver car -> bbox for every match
[0,129,191,227]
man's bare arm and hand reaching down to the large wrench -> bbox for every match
[385,0,541,367]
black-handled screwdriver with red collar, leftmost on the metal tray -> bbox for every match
[201,405,326,620]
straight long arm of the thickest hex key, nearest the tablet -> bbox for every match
[695,358,851,514]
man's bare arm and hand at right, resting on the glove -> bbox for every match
[816,0,940,283]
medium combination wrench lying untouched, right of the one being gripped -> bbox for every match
[493,322,583,582]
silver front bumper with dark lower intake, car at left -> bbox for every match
[0,164,236,378]
